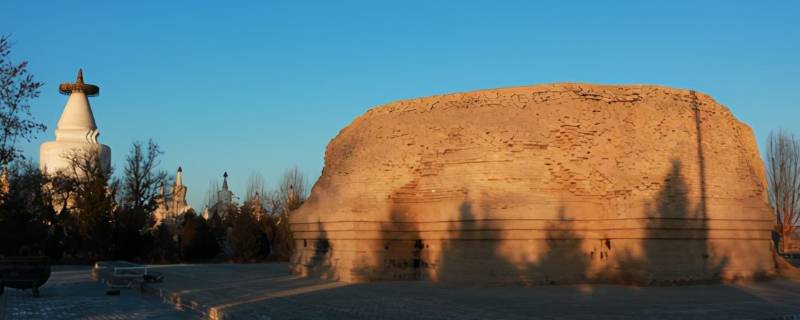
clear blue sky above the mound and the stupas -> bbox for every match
[0,0,800,209]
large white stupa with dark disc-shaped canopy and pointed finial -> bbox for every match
[39,70,111,174]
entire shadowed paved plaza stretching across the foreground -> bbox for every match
[0,263,800,320]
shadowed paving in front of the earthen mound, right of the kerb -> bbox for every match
[144,263,800,320]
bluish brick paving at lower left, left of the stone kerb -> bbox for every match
[0,267,197,320]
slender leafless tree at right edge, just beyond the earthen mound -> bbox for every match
[767,130,800,251]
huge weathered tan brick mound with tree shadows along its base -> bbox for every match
[291,84,775,284]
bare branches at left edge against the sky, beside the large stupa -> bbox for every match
[0,36,47,164]
